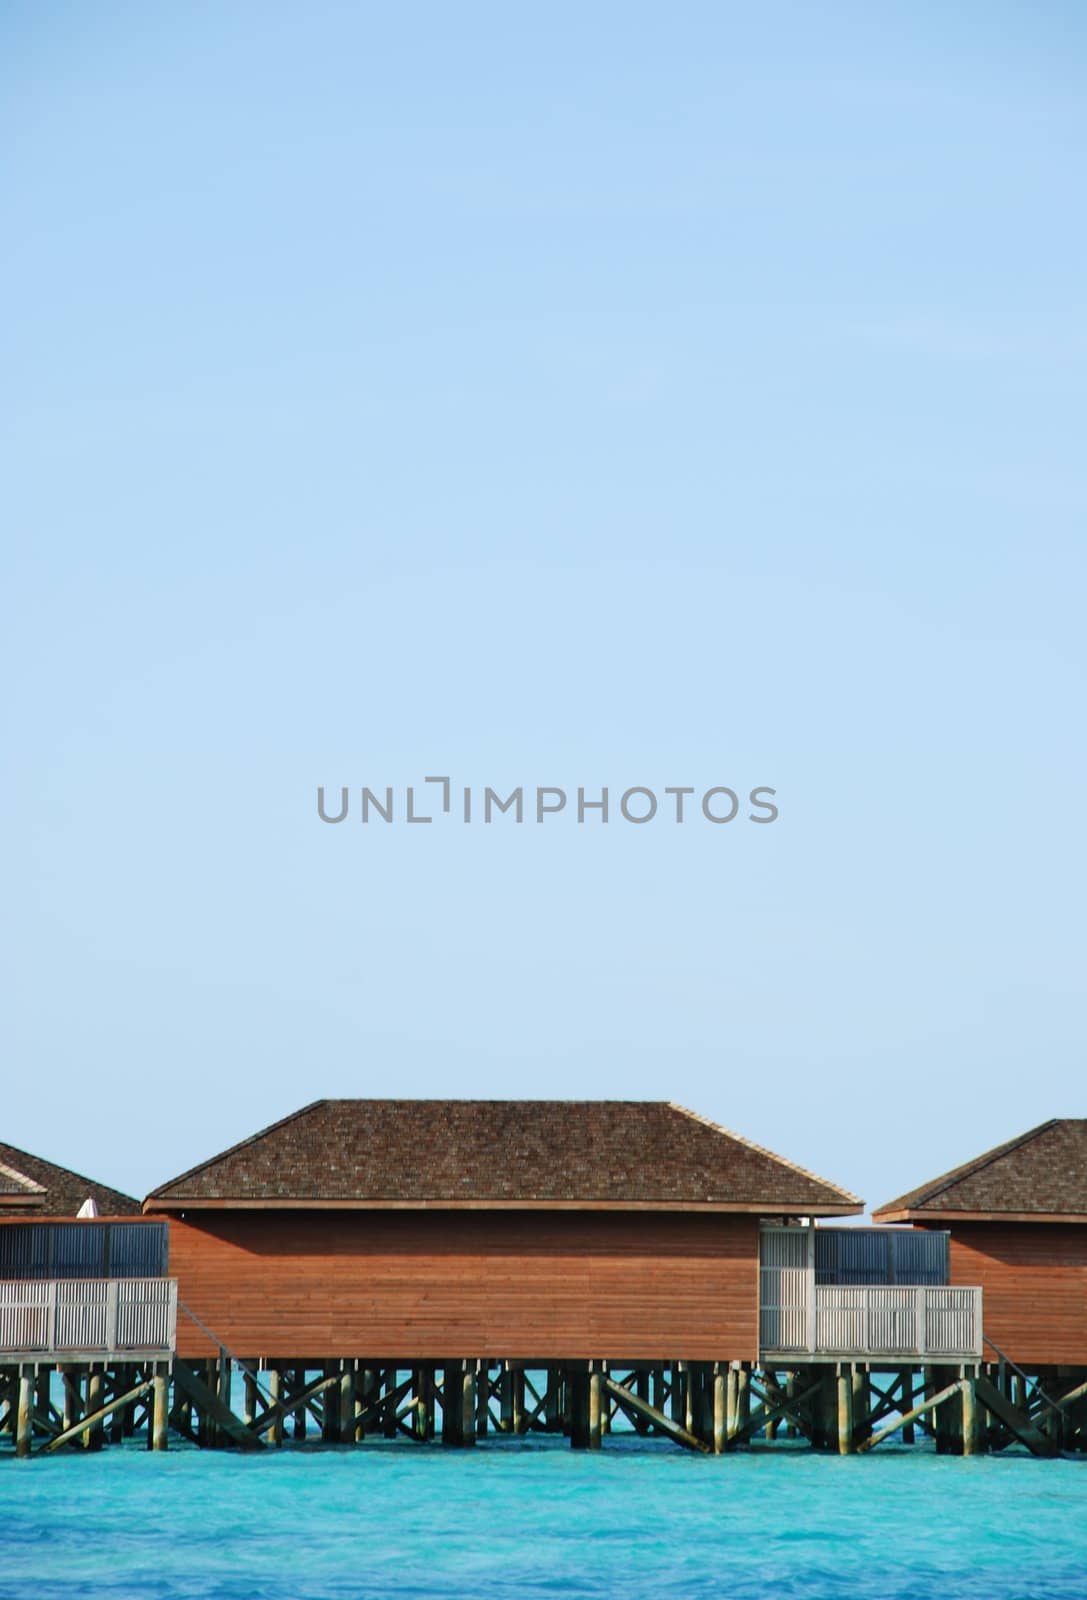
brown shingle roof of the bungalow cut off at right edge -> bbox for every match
[872,1117,1087,1219]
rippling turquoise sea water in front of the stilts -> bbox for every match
[0,1438,1087,1600]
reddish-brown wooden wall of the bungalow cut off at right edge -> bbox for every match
[943,1222,1087,1366]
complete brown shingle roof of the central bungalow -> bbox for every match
[144,1099,861,1214]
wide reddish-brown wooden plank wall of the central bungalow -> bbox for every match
[159,1211,759,1360]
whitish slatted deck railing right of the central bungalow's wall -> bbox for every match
[760,1285,981,1360]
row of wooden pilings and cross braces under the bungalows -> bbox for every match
[0,1352,1087,1456]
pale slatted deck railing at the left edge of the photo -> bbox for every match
[0,1278,178,1360]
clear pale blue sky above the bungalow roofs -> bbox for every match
[0,0,1087,1203]
